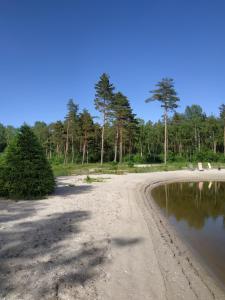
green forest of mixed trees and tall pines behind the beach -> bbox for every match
[0,73,225,164]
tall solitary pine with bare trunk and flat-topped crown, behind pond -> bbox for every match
[146,78,180,164]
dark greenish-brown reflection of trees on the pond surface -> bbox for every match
[152,181,225,229]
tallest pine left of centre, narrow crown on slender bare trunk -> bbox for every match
[95,73,114,164]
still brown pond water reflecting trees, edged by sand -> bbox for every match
[152,182,225,287]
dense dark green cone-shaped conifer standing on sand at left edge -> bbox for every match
[0,125,55,199]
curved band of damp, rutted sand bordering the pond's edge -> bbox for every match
[136,172,225,299]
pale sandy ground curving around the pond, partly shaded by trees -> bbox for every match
[0,170,225,300]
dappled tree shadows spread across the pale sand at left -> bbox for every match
[0,182,141,300]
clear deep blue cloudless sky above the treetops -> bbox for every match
[0,0,225,126]
